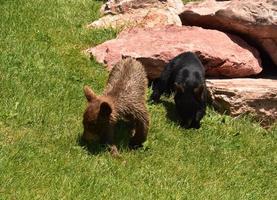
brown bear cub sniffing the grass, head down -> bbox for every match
[82,58,149,154]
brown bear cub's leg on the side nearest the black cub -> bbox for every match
[129,112,149,149]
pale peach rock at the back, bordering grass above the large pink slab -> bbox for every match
[88,0,184,28]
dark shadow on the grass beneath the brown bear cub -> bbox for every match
[77,121,131,155]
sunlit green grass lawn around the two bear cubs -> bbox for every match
[0,0,277,200]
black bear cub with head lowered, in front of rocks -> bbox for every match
[150,52,207,129]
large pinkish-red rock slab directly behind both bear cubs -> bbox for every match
[87,26,262,79]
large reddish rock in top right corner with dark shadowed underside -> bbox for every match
[180,0,277,65]
